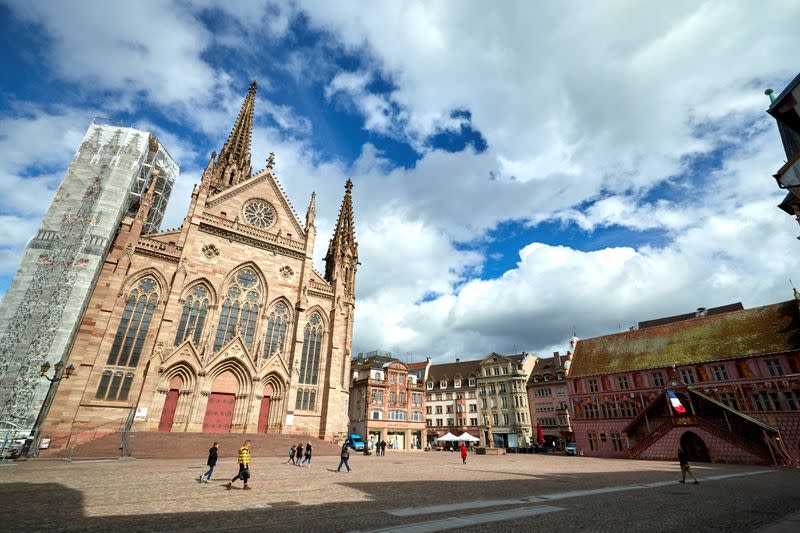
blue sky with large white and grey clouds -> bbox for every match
[0,0,800,362]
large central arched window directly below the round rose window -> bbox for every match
[214,268,261,351]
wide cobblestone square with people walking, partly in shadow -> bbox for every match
[0,450,800,532]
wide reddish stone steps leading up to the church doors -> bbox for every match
[40,431,340,461]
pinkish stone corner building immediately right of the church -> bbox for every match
[350,356,426,450]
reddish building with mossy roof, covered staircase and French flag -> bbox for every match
[567,297,800,464]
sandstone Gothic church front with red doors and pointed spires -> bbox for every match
[42,82,358,447]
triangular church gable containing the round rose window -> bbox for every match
[205,170,305,240]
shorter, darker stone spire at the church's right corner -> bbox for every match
[325,178,358,294]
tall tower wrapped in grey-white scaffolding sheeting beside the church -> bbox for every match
[0,121,179,428]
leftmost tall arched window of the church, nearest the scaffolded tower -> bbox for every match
[107,276,158,366]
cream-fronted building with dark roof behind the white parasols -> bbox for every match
[425,359,482,446]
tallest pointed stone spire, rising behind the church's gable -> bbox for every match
[211,80,256,192]
